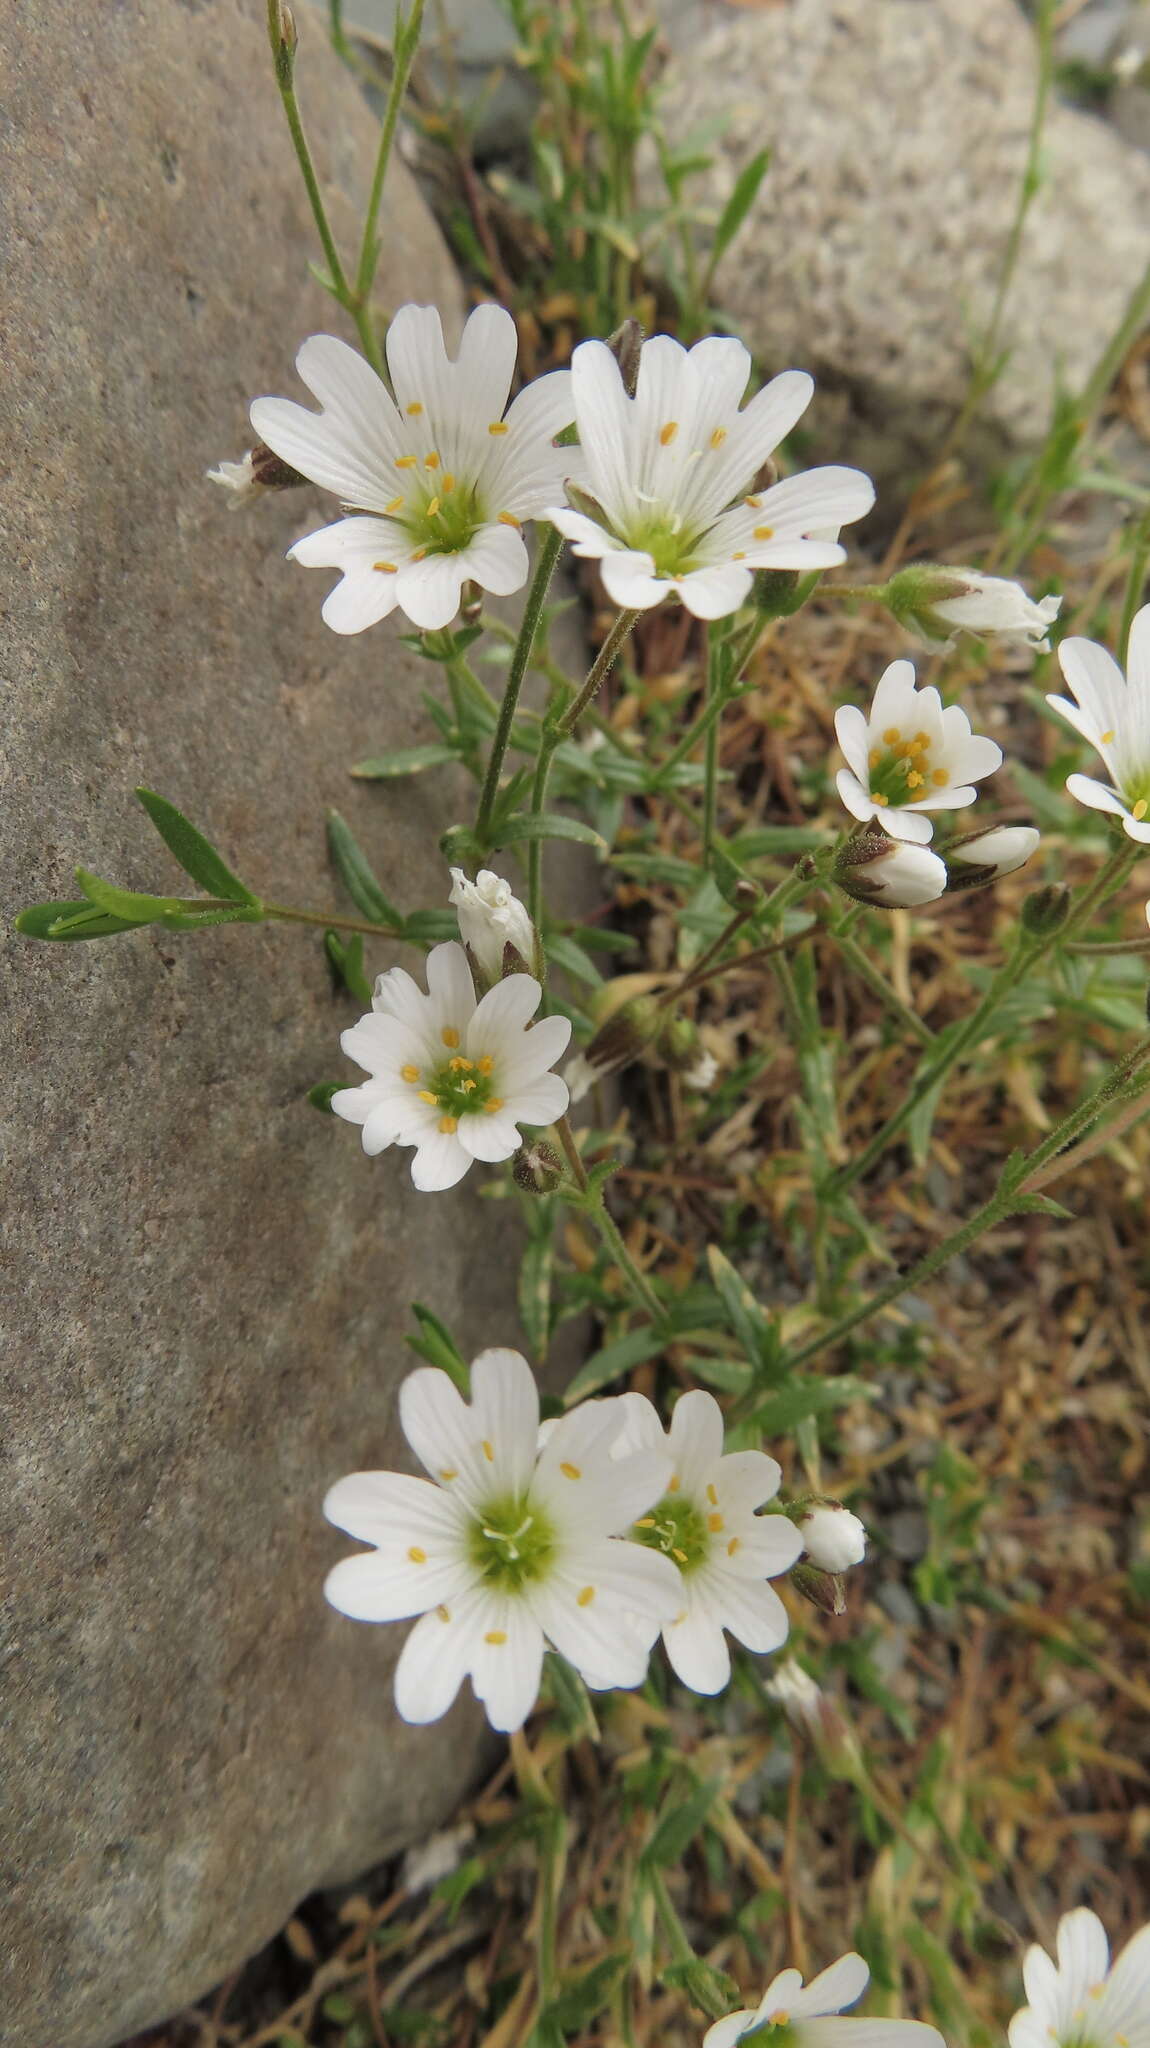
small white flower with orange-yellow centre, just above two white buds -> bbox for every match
[835,662,1003,846]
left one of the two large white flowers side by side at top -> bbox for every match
[252,305,577,633]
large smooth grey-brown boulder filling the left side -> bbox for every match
[0,0,516,2048]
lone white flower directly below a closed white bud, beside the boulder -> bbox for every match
[331,942,571,1192]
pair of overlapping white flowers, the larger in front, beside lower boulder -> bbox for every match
[323,1352,802,1731]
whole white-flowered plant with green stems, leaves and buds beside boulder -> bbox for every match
[18,0,1150,2048]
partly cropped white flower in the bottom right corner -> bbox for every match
[1009,1907,1150,2048]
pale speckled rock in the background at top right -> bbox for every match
[665,0,1150,475]
